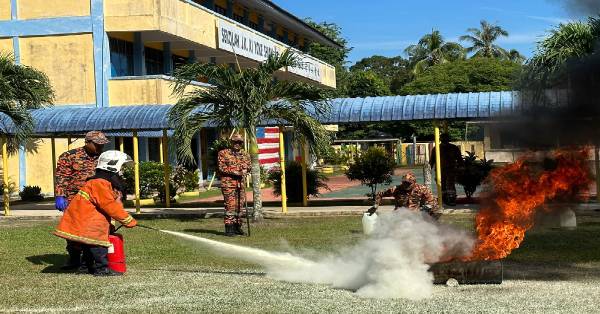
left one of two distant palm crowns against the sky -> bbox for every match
[404,30,464,74]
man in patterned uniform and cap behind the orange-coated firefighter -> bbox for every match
[54,131,109,270]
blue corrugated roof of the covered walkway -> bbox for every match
[0,92,520,137]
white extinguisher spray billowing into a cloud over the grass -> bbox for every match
[163,209,474,300]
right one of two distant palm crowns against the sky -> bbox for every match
[460,20,508,58]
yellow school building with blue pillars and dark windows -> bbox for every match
[0,0,336,193]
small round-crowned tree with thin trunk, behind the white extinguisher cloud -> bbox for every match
[346,147,396,200]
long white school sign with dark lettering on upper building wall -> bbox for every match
[217,20,321,82]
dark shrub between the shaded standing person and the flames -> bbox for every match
[456,152,494,199]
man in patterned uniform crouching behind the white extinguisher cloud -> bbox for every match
[376,172,440,219]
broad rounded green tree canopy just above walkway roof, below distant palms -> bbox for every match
[401,58,521,95]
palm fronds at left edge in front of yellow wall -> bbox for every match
[0,54,54,153]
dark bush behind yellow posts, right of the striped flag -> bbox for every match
[268,161,329,202]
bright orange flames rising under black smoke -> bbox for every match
[467,149,592,260]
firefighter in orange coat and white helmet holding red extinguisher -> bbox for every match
[54,150,137,276]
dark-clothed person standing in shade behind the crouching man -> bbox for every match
[429,133,463,206]
